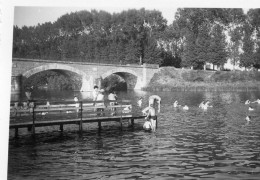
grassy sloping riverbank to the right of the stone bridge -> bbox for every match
[143,67,260,91]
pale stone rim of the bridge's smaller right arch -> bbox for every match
[101,68,142,89]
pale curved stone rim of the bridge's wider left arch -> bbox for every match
[22,63,93,91]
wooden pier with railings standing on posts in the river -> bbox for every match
[9,100,145,137]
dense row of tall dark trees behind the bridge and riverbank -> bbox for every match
[13,8,260,69]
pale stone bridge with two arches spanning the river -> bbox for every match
[11,58,159,93]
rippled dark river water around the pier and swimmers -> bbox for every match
[8,91,260,179]
